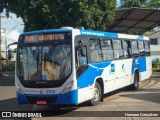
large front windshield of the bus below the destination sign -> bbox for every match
[17,43,71,81]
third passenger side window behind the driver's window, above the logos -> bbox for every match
[112,40,123,59]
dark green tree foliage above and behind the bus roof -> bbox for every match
[0,0,116,31]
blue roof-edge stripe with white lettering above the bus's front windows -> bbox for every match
[80,30,118,38]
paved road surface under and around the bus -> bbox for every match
[0,72,160,120]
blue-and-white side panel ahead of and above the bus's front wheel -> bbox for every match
[77,62,110,103]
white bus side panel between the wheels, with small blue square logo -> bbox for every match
[102,59,133,93]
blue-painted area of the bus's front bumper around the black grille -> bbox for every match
[17,90,78,104]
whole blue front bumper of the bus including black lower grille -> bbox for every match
[17,90,78,105]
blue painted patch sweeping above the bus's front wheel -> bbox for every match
[77,62,111,88]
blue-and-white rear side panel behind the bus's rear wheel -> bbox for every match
[138,57,152,81]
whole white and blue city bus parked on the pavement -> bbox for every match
[15,27,152,105]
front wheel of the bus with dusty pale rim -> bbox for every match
[89,82,102,106]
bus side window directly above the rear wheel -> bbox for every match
[131,41,139,57]
